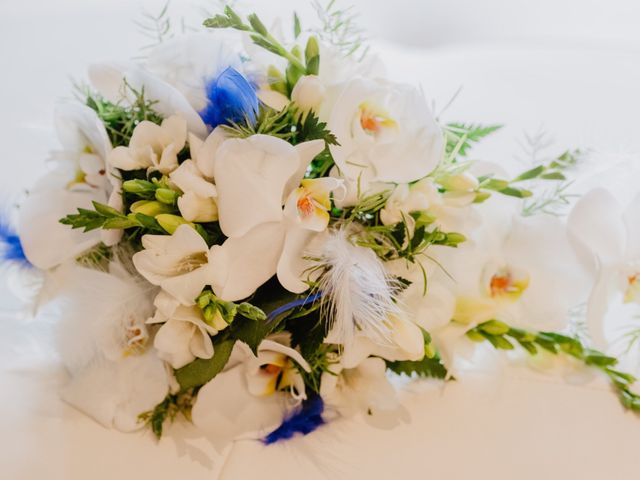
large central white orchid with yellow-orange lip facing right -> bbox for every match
[213,135,341,301]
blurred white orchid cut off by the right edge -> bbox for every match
[568,188,640,348]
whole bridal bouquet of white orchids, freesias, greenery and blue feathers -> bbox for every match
[2,1,640,443]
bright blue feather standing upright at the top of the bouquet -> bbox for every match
[200,67,259,128]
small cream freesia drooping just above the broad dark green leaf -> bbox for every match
[147,292,228,369]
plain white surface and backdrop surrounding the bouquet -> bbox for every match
[0,0,640,480]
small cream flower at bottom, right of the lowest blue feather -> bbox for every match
[320,357,399,416]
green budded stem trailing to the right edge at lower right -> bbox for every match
[467,320,640,412]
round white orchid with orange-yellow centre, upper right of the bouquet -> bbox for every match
[321,78,444,191]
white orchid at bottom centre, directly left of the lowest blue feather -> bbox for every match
[191,337,310,440]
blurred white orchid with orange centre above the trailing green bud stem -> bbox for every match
[443,212,585,330]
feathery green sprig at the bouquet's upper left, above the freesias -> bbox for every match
[86,82,163,147]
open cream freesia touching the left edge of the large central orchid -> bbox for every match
[133,225,226,305]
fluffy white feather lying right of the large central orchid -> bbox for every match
[318,230,399,347]
